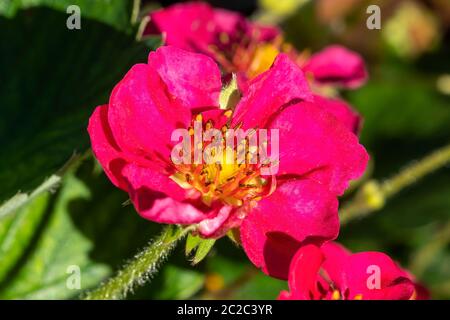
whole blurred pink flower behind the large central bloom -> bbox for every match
[146,2,367,133]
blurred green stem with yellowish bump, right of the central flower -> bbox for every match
[339,145,450,224]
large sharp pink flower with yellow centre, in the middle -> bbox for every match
[88,46,368,277]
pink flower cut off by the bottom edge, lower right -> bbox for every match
[279,242,428,300]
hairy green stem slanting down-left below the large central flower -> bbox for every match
[83,225,190,300]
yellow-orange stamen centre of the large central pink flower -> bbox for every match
[171,110,274,207]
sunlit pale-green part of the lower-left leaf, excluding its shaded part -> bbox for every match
[0,171,110,299]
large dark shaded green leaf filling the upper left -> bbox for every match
[0,6,153,213]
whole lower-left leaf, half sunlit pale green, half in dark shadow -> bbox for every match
[0,160,163,299]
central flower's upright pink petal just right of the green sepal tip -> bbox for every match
[232,54,313,129]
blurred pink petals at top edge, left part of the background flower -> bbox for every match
[144,2,279,60]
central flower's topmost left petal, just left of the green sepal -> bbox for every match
[148,46,222,109]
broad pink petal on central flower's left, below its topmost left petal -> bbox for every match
[108,64,192,161]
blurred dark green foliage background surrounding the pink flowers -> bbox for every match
[0,0,450,299]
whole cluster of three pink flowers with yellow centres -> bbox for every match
[88,3,424,299]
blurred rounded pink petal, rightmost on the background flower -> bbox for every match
[303,45,367,88]
